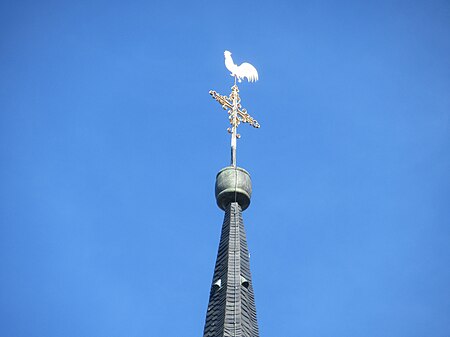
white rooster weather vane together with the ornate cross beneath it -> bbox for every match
[209,50,260,167]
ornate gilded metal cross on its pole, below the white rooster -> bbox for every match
[209,84,260,167]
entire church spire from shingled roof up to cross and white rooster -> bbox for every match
[203,52,259,337]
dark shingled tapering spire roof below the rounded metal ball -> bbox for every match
[203,202,259,337]
